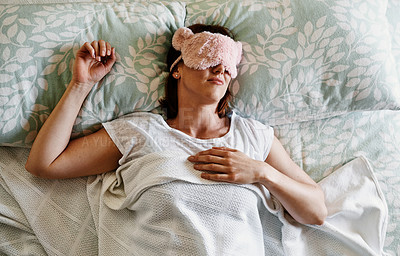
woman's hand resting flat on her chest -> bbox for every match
[188,147,266,184]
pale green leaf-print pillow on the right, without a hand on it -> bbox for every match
[186,0,400,125]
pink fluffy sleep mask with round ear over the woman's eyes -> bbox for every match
[170,28,242,78]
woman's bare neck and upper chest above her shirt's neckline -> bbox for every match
[167,105,230,139]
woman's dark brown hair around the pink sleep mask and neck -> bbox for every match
[159,24,234,119]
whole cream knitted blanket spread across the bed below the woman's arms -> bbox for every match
[0,148,387,256]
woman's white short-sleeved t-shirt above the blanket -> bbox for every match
[103,112,273,165]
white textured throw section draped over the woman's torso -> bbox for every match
[88,152,282,255]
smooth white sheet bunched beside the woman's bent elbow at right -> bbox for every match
[279,157,388,256]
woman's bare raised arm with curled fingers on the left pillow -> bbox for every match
[25,40,121,178]
